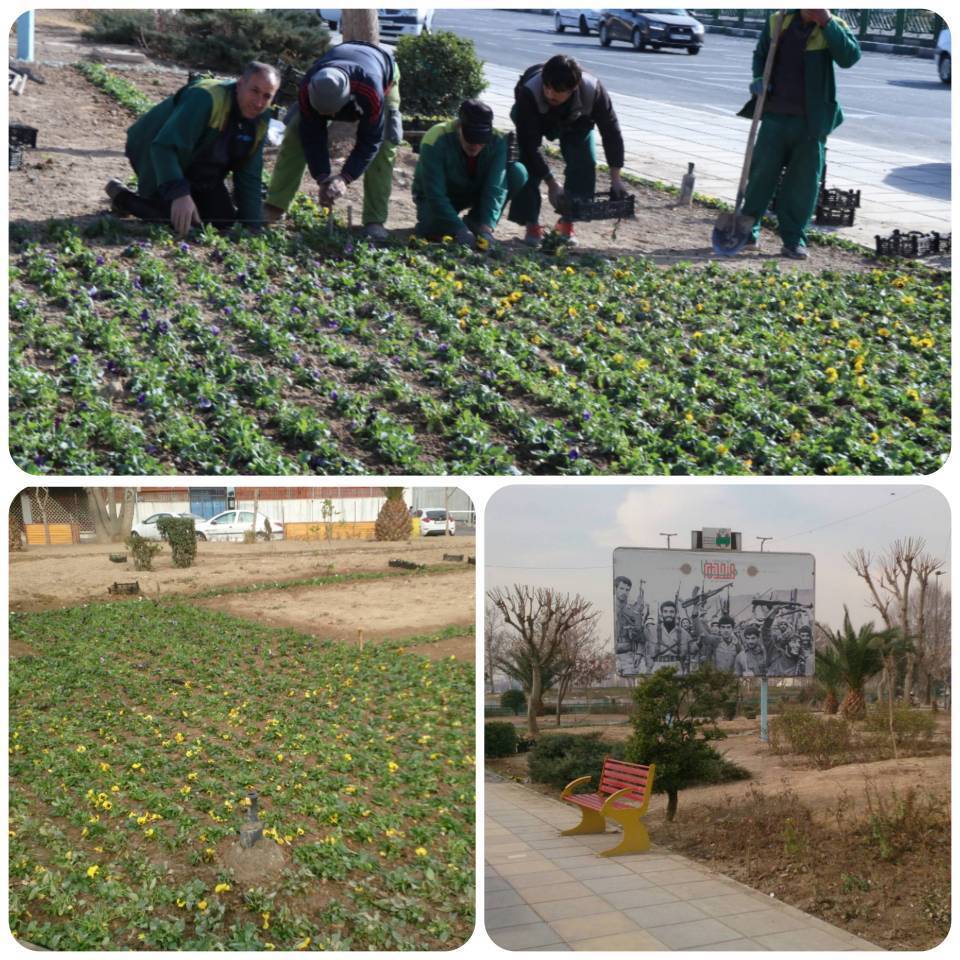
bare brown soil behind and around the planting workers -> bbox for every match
[10,10,928,271]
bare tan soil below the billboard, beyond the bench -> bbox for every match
[487,716,950,825]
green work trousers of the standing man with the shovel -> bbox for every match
[743,113,826,247]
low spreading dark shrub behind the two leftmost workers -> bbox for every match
[88,10,330,73]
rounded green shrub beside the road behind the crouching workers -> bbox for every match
[397,31,487,117]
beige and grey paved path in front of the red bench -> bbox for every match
[484,779,881,951]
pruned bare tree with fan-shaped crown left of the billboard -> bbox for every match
[487,584,599,736]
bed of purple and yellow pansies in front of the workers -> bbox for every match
[10,207,950,474]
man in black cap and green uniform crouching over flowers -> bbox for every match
[413,100,527,248]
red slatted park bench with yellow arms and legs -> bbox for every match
[560,757,656,857]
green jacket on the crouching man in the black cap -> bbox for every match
[413,120,507,229]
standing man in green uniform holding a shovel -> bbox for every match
[739,10,860,260]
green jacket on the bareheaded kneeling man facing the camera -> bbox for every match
[127,80,269,222]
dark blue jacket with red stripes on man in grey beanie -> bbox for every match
[298,42,396,183]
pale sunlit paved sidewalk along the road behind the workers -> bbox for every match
[482,63,951,249]
